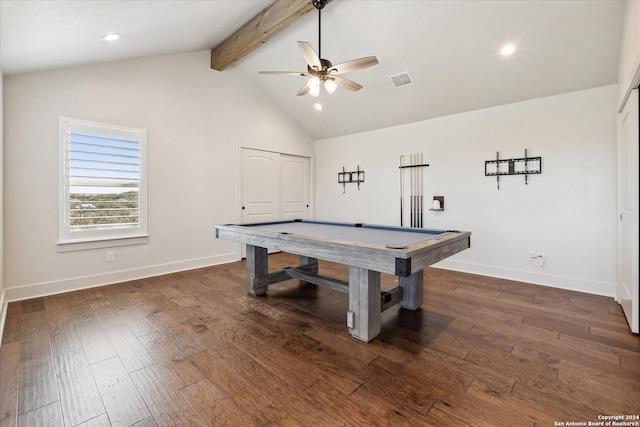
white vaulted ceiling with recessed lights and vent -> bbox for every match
[0,0,624,139]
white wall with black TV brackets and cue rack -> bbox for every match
[315,85,617,296]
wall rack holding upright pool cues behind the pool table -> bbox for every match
[399,153,429,228]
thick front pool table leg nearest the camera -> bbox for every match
[347,266,380,342]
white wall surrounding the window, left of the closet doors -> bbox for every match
[4,52,313,300]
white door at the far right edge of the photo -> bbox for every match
[616,89,640,333]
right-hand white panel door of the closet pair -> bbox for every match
[280,154,310,220]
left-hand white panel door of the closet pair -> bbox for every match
[241,148,280,224]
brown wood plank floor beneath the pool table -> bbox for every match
[0,254,640,427]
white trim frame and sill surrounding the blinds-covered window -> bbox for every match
[58,117,148,252]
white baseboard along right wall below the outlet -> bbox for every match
[433,259,616,298]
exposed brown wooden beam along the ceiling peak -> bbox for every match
[211,0,331,71]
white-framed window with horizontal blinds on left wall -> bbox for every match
[59,117,147,244]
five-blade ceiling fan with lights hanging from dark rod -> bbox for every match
[260,0,378,96]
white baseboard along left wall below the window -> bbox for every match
[4,253,238,304]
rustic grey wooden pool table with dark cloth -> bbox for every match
[215,220,471,342]
